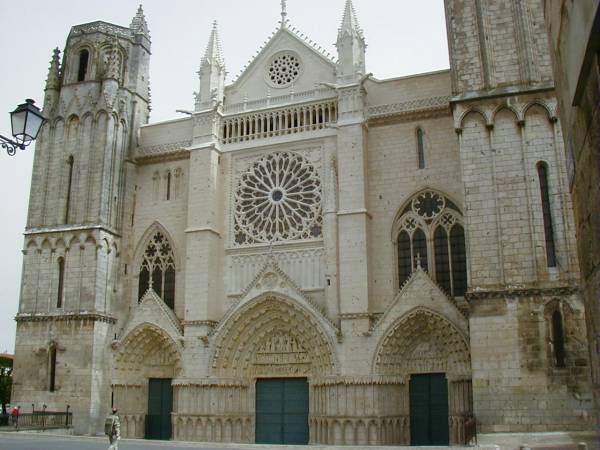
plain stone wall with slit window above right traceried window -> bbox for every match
[368,114,463,312]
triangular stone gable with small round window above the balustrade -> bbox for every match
[225,27,335,104]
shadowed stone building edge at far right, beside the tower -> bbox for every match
[544,0,600,424]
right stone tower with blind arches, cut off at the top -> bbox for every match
[445,0,591,433]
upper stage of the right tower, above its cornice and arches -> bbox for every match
[445,0,552,95]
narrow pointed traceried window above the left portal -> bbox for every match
[138,231,175,309]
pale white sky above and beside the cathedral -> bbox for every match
[0,0,448,353]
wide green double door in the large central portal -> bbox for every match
[255,378,308,444]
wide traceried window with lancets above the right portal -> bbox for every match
[395,190,467,297]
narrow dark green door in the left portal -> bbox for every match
[145,378,173,440]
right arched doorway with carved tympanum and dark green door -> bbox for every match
[374,308,472,445]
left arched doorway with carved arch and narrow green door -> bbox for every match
[112,323,181,439]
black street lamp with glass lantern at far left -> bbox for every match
[0,98,46,156]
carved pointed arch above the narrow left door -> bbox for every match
[115,322,182,382]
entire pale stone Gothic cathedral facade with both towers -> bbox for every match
[13,0,595,445]
